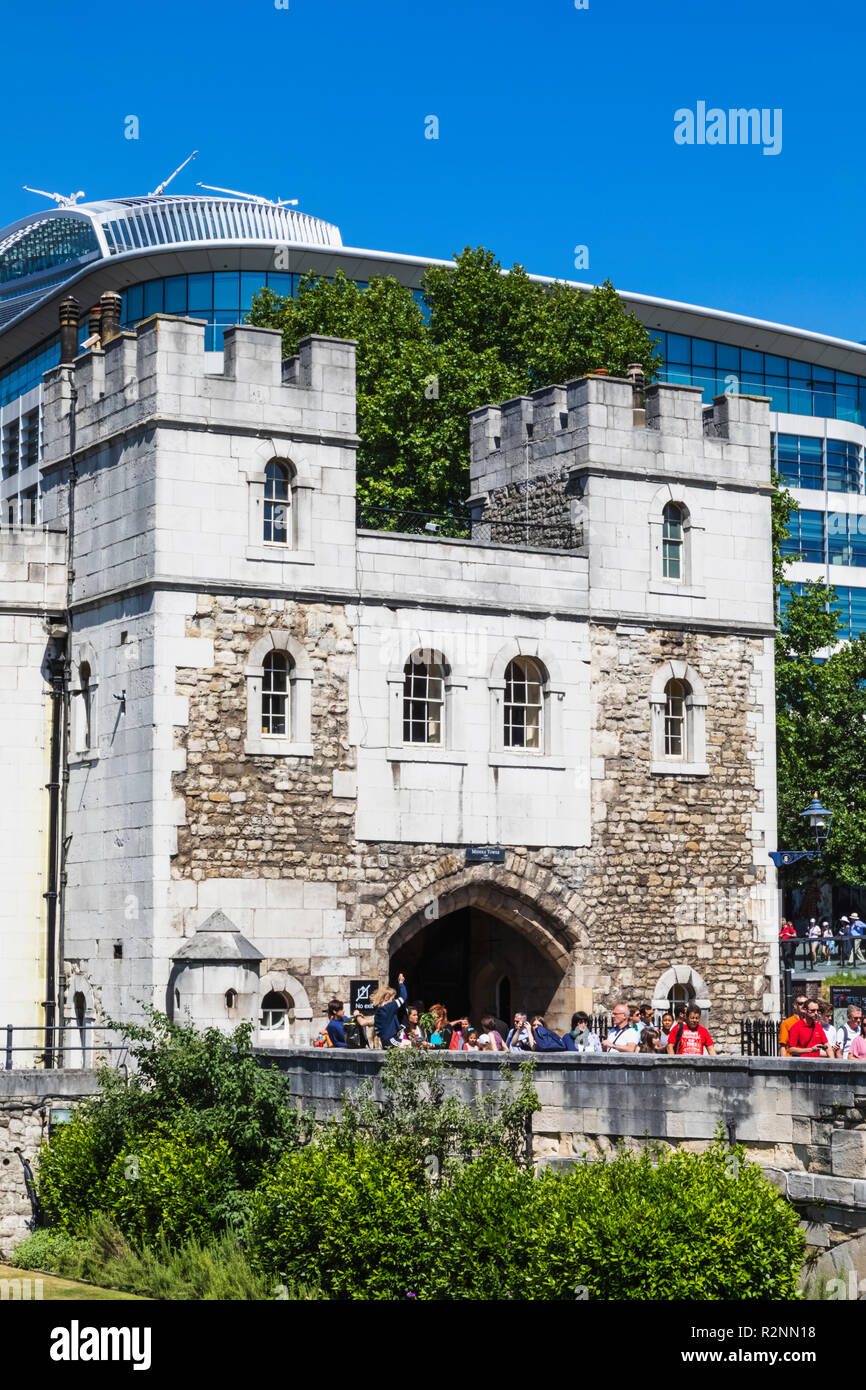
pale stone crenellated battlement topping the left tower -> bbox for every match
[44,314,356,468]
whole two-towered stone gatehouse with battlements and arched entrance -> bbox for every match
[0,317,777,1047]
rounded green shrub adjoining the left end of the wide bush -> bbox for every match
[245,1144,431,1298]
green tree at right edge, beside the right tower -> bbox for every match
[773,478,866,883]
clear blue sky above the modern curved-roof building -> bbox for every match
[0,0,866,341]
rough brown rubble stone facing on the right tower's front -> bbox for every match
[582,627,767,1043]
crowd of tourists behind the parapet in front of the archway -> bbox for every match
[316,974,716,1056]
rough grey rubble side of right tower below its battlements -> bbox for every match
[473,473,584,550]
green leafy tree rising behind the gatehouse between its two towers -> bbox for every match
[250,247,659,517]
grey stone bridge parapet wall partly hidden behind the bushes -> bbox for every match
[6,1048,866,1276]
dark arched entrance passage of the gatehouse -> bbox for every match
[391,908,564,1024]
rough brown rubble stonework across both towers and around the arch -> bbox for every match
[172,596,769,1047]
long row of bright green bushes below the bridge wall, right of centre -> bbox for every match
[246,1141,805,1301]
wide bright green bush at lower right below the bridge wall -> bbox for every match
[423,1141,805,1301]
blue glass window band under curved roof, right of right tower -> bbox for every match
[649,328,866,424]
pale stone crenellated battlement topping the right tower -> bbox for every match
[470,375,770,499]
